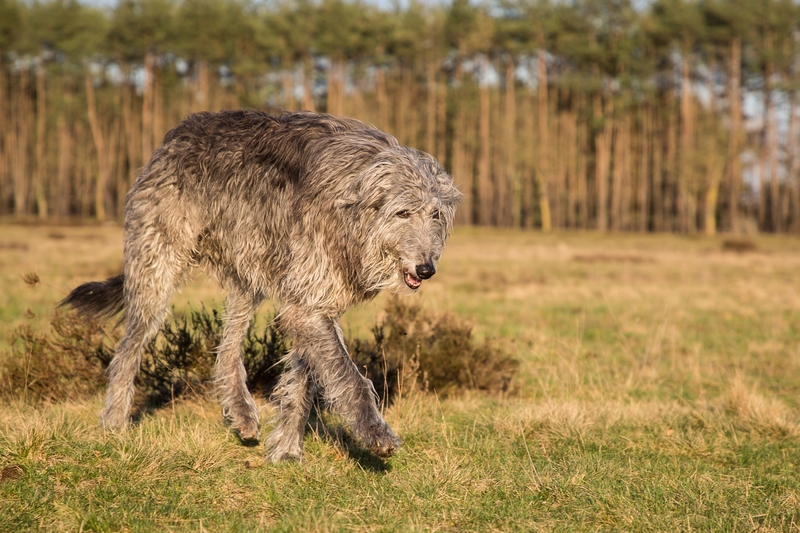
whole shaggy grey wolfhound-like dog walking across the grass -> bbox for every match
[62,110,460,461]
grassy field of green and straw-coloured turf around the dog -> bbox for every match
[0,225,800,531]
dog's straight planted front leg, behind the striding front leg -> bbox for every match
[267,350,316,463]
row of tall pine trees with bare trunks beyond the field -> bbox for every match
[0,0,800,234]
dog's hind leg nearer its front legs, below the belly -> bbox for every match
[214,288,264,443]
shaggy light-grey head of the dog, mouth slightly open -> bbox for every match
[346,146,461,292]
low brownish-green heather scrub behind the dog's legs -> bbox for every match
[0,299,518,407]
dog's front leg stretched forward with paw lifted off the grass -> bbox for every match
[281,310,401,457]
